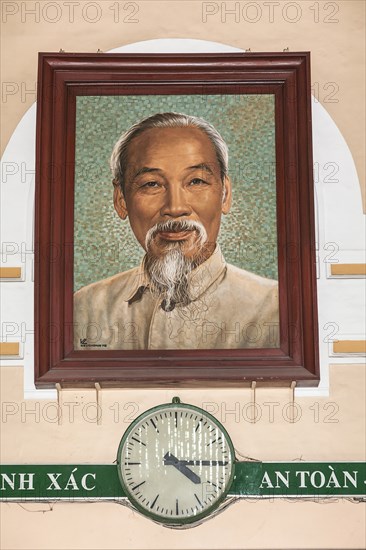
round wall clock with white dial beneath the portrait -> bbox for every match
[118,403,235,524]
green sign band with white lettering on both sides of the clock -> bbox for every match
[0,462,366,501]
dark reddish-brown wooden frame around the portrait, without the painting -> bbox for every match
[35,52,319,388]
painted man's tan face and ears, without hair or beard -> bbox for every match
[114,127,231,261]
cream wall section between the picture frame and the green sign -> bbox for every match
[0,365,366,464]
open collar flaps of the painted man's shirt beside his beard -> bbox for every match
[122,244,226,302]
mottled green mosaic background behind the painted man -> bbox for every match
[74,95,277,290]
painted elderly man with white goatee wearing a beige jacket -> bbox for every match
[74,112,279,350]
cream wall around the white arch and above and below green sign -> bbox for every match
[0,0,366,550]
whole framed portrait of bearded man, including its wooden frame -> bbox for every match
[35,53,319,388]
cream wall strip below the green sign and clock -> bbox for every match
[0,500,366,550]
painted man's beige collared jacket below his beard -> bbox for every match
[74,247,279,350]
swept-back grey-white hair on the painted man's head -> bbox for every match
[110,112,229,192]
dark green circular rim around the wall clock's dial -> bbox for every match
[117,397,236,527]
